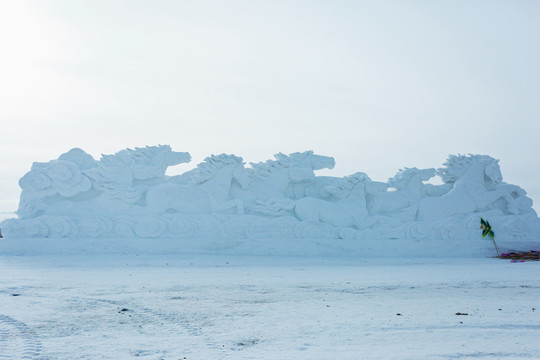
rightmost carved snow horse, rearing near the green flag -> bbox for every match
[417,155,517,220]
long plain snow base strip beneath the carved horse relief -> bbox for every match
[0,238,512,258]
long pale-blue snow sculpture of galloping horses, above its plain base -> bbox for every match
[0,145,540,245]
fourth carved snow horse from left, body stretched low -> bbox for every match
[257,172,370,229]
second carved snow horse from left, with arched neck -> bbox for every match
[146,154,250,214]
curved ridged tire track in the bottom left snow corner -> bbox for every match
[0,314,42,360]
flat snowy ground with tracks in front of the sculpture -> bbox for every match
[0,254,540,359]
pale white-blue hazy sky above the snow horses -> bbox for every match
[0,0,540,211]
